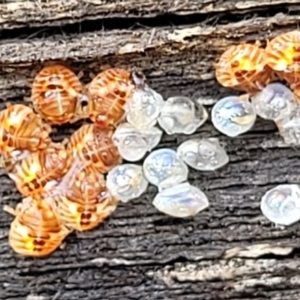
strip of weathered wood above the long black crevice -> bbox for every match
[0,0,298,29]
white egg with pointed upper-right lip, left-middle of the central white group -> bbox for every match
[112,123,163,162]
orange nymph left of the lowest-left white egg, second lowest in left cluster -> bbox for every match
[54,165,118,231]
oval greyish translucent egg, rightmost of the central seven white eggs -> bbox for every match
[177,138,229,171]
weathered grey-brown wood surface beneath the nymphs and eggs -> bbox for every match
[0,0,300,300]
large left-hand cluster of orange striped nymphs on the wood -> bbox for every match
[0,65,144,257]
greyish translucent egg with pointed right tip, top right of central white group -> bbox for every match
[158,96,208,135]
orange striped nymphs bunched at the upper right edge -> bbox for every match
[216,31,300,97]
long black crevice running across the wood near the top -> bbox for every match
[0,5,292,44]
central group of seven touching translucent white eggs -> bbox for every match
[107,83,229,218]
